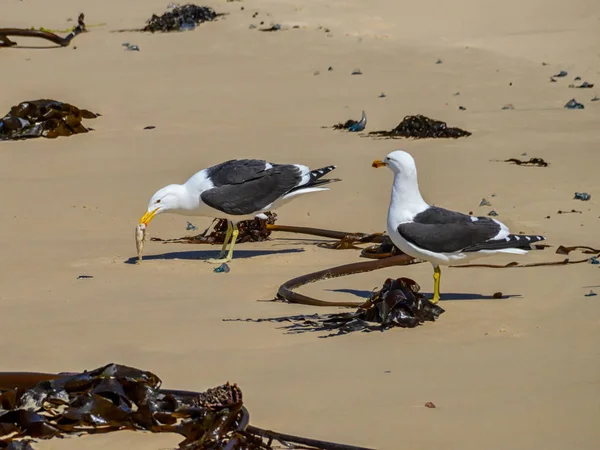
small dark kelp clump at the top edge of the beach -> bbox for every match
[142,4,223,33]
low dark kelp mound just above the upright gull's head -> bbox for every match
[369,114,472,139]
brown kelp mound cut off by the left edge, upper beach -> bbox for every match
[0,99,100,140]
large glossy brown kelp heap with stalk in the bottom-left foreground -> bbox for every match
[0,364,366,450]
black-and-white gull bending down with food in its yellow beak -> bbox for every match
[140,159,341,263]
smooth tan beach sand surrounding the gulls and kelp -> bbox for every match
[0,0,600,450]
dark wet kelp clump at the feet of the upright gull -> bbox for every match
[229,278,444,337]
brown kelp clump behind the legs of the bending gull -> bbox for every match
[150,212,277,244]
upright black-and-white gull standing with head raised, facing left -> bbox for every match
[372,150,545,303]
